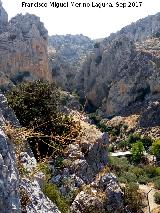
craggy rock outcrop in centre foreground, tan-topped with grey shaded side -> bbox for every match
[50,112,124,213]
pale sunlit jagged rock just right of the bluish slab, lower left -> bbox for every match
[20,152,60,213]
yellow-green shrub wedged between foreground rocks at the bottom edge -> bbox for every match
[42,183,69,213]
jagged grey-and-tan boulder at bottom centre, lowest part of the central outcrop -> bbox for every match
[71,173,124,213]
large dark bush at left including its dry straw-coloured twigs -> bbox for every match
[7,81,80,159]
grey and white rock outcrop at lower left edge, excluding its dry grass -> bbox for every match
[0,94,60,213]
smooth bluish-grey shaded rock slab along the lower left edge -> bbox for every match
[0,128,21,213]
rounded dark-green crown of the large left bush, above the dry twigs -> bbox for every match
[7,81,60,128]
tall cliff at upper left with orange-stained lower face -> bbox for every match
[0,5,51,84]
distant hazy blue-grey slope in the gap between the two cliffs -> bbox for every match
[48,35,94,91]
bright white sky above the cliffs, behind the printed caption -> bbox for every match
[2,0,160,39]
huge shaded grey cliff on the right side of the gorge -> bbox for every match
[77,13,160,120]
